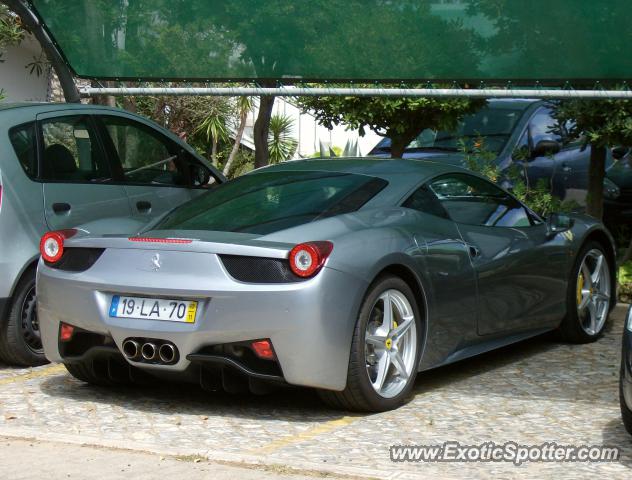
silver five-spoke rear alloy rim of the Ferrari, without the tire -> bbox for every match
[365,289,417,398]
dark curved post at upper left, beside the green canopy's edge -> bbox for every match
[3,0,81,103]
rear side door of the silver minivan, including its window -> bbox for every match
[37,110,131,230]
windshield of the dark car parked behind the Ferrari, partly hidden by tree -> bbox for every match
[376,105,524,154]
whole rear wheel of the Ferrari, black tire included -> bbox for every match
[319,275,423,412]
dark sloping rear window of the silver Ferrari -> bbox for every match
[153,172,388,235]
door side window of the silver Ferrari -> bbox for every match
[429,174,531,227]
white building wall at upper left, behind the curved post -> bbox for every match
[0,35,48,102]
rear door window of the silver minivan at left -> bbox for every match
[41,115,111,182]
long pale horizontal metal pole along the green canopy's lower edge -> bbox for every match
[80,87,632,100]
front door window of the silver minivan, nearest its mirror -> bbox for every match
[100,116,188,186]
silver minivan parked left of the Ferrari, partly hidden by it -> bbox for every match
[0,104,225,365]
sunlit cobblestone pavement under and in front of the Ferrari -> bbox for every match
[0,306,632,479]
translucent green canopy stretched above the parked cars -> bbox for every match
[32,0,632,86]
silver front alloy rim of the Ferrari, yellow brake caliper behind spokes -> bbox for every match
[577,249,610,336]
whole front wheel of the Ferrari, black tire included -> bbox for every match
[559,241,614,344]
